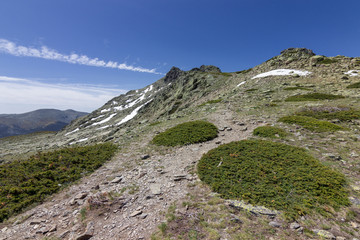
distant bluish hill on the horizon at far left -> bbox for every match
[0,109,88,138]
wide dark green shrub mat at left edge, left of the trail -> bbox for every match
[0,143,117,222]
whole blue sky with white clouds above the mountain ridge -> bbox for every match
[0,0,360,113]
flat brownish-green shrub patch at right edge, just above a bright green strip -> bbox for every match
[296,106,360,121]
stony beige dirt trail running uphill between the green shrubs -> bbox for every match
[0,111,262,240]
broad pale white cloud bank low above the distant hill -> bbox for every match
[0,76,126,114]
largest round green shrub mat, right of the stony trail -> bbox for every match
[197,140,349,219]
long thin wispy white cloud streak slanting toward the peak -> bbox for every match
[0,38,161,74]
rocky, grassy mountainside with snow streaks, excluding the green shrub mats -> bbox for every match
[0,49,360,240]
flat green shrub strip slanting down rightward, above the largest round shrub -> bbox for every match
[279,116,346,132]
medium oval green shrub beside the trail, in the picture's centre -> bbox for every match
[152,121,217,146]
